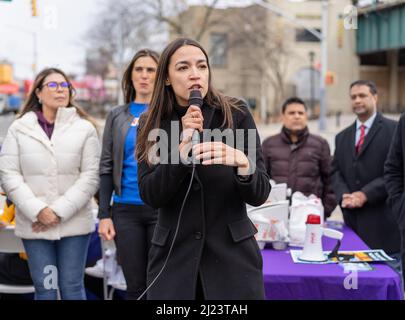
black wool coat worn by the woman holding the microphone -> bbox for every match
[138,104,271,299]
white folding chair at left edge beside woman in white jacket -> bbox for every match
[0,226,35,294]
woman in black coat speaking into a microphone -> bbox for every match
[136,38,270,300]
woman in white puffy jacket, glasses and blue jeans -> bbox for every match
[0,68,100,300]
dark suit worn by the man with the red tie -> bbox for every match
[332,113,400,253]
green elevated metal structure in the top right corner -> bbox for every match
[356,0,405,112]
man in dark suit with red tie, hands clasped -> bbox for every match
[331,80,401,272]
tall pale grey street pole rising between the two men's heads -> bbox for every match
[319,0,329,131]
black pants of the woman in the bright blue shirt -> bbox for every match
[112,203,157,300]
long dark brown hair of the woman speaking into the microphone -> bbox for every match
[136,38,240,163]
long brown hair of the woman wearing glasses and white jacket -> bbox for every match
[18,68,97,129]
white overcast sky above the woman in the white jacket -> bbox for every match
[0,0,258,79]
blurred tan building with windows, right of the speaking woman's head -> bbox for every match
[170,0,360,120]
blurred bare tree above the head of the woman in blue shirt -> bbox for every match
[85,0,223,76]
